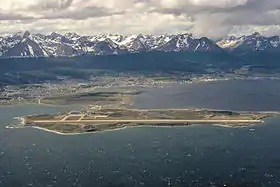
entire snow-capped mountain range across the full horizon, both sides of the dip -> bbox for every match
[0,31,280,58]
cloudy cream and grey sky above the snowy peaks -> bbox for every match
[0,0,280,39]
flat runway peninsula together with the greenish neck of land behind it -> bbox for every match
[7,88,280,134]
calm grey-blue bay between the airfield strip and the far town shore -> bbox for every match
[134,80,280,111]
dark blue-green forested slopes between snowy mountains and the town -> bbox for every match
[0,52,280,86]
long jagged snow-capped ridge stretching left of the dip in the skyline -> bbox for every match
[0,31,222,57]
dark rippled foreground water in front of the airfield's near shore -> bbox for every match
[0,93,280,187]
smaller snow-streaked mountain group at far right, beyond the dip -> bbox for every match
[217,33,280,52]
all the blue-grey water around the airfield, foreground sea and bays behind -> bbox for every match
[0,81,280,187]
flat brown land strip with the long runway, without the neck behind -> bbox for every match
[19,106,278,134]
